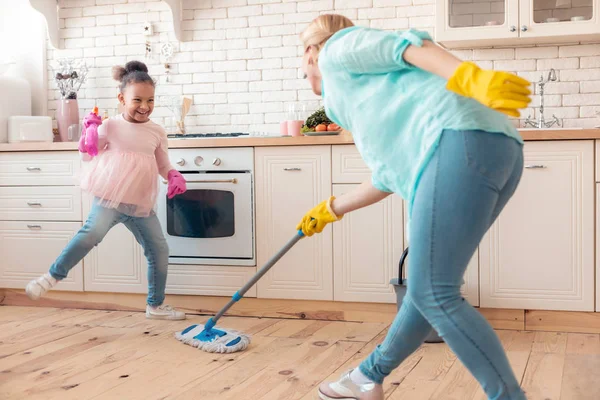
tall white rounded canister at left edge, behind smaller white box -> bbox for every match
[0,76,31,143]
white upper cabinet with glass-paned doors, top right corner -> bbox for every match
[435,0,600,48]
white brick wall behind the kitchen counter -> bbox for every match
[48,0,600,133]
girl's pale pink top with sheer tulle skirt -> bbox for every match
[81,115,173,217]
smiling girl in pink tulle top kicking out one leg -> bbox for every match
[26,61,186,320]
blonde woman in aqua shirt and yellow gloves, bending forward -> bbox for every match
[298,15,530,400]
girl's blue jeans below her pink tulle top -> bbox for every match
[50,201,169,306]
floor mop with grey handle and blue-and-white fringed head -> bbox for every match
[175,231,304,353]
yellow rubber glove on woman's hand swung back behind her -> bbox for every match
[446,62,531,117]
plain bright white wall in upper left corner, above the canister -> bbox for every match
[0,0,48,115]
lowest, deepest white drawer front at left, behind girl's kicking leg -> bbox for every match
[0,221,83,291]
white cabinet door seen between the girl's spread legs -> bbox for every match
[83,194,148,293]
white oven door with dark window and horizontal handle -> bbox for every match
[158,172,255,265]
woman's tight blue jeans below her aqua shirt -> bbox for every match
[360,130,525,400]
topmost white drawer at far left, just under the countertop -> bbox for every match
[0,151,81,186]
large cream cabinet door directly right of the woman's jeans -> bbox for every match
[480,141,594,311]
